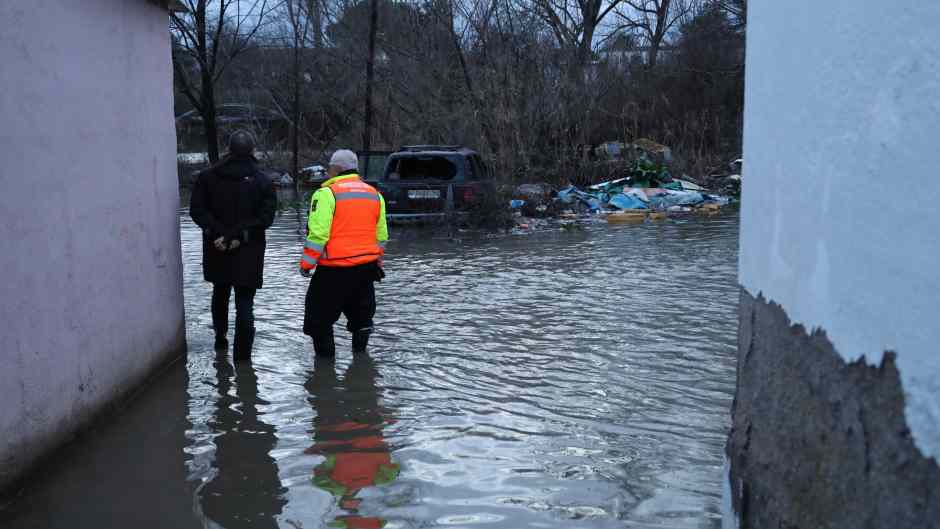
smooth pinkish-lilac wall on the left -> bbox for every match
[0,0,185,488]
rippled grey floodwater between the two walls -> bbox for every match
[0,194,738,529]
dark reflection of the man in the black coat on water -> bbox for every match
[199,355,287,529]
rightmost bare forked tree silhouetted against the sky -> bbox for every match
[617,0,695,69]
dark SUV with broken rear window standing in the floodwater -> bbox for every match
[370,145,496,221]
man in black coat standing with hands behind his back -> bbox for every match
[189,130,277,360]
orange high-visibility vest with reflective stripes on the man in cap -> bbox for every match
[319,178,385,267]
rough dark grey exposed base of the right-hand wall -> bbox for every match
[728,291,940,529]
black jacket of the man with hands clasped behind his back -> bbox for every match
[189,159,277,288]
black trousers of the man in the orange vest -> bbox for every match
[304,263,380,336]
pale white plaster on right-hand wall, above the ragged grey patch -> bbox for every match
[740,0,940,460]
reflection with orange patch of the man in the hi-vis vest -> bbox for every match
[306,354,399,529]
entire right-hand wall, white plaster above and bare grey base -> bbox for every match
[729,0,940,527]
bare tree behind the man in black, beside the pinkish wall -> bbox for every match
[170,0,269,163]
